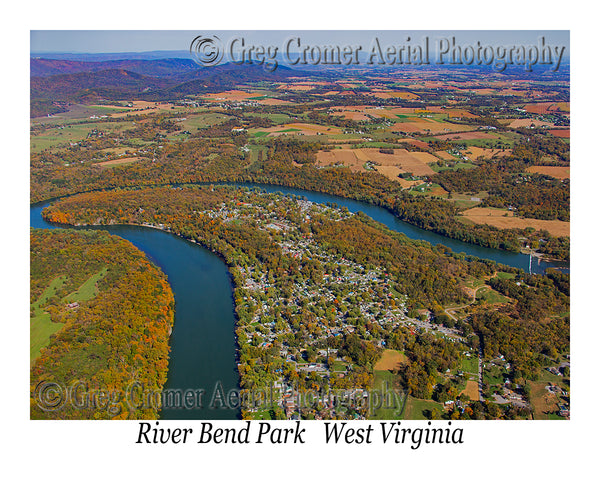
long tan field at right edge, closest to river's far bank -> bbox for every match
[462,207,571,237]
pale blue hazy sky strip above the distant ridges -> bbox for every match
[30,30,569,56]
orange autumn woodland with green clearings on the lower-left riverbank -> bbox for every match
[30,229,174,419]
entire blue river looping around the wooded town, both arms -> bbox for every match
[30,184,568,420]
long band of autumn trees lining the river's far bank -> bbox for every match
[31,139,570,260]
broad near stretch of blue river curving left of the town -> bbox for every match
[30,203,239,420]
